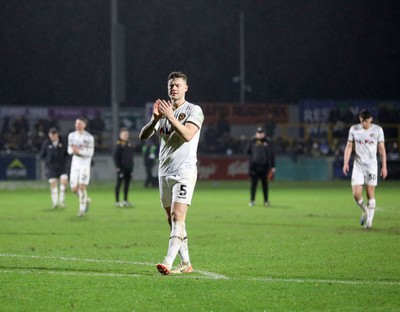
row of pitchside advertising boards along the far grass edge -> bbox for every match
[0,153,400,181]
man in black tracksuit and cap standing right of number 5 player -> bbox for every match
[246,128,275,207]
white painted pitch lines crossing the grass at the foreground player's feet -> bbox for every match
[0,254,400,286]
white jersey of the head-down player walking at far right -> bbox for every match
[348,124,385,167]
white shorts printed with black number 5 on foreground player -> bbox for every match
[159,174,197,208]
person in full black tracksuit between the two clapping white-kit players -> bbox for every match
[113,128,134,207]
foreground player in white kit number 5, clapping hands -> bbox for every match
[139,72,204,275]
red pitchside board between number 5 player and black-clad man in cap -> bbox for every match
[197,156,249,180]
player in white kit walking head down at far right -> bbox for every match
[343,109,387,228]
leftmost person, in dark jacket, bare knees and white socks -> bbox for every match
[40,128,69,208]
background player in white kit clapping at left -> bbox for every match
[68,117,94,216]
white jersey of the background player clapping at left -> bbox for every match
[68,131,94,167]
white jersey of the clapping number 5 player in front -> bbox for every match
[155,102,204,176]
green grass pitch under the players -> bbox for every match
[0,181,400,311]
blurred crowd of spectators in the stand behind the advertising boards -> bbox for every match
[0,107,400,160]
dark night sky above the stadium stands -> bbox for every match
[0,0,400,106]
